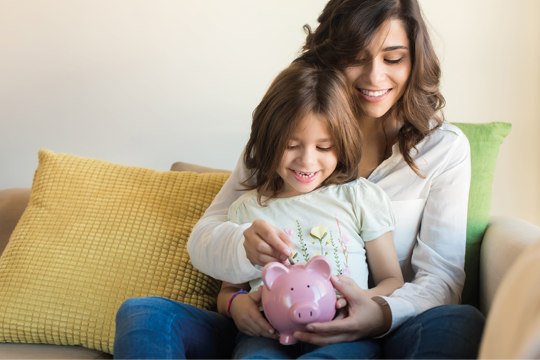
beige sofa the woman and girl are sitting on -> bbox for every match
[0,155,540,360]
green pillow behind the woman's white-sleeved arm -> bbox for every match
[453,122,512,307]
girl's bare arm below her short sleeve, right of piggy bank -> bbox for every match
[365,231,404,297]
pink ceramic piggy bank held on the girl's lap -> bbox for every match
[262,255,336,345]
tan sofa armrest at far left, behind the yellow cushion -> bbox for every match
[0,188,30,255]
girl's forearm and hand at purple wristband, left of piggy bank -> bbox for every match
[217,281,277,339]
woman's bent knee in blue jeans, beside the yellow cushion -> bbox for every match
[114,297,238,360]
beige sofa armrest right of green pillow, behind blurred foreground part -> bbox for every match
[480,216,540,315]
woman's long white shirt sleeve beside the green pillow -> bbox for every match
[373,129,471,332]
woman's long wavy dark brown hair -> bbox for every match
[296,0,445,176]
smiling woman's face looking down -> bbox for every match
[345,20,412,119]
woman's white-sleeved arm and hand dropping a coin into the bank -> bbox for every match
[187,153,294,284]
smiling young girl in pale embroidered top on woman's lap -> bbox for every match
[218,63,403,359]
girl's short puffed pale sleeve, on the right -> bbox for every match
[356,179,396,241]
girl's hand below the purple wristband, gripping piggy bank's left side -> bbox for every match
[229,287,278,339]
